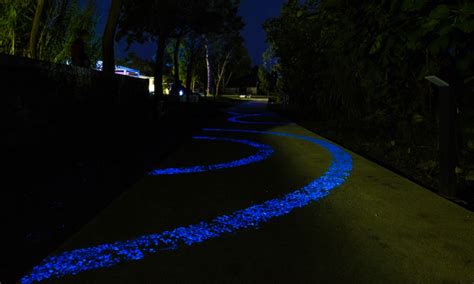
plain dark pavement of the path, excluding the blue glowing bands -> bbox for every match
[19,98,474,283]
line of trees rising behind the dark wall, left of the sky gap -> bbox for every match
[0,0,250,101]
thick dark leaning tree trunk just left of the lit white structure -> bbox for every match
[102,0,122,74]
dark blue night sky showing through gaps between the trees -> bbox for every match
[92,0,286,64]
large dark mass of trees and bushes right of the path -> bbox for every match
[260,0,474,197]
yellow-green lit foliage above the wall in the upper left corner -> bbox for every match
[0,0,100,63]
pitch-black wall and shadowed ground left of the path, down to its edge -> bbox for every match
[0,55,151,283]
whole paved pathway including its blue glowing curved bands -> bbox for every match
[23,101,474,283]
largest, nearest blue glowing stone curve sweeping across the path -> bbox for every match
[21,129,352,283]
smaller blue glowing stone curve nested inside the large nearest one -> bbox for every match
[149,136,274,176]
